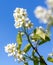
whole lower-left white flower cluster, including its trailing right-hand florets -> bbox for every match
[5,43,25,61]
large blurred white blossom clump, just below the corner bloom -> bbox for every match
[34,6,53,24]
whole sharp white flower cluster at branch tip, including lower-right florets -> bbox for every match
[13,8,33,28]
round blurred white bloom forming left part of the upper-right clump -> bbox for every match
[34,6,47,18]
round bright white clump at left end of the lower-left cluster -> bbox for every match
[5,43,16,56]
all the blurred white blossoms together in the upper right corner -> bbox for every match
[34,0,53,23]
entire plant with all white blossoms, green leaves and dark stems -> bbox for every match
[5,0,53,65]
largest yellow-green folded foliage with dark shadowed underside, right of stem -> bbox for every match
[32,28,50,45]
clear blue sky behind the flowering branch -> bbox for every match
[0,0,53,65]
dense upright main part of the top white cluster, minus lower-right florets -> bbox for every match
[13,8,27,28]
